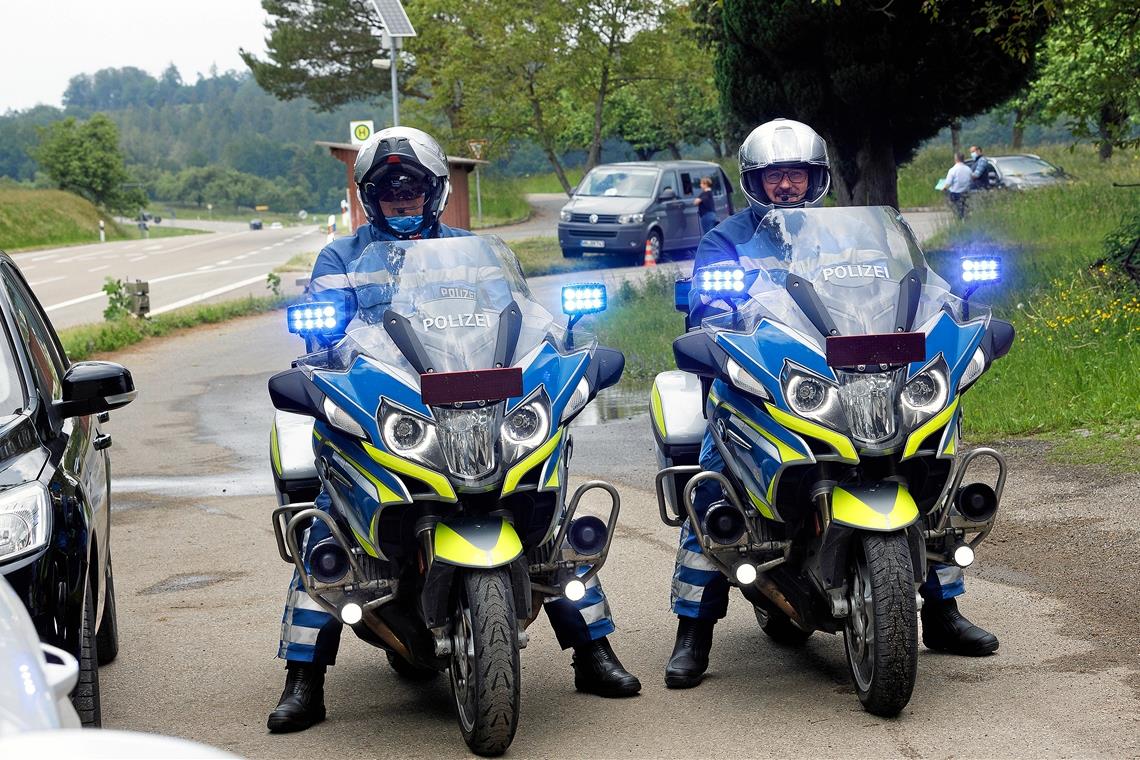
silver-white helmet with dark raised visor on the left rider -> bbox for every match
[352,126,451,240]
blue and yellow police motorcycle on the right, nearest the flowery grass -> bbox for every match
[651,206,1013,717]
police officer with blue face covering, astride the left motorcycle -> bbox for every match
[268,126,641,733]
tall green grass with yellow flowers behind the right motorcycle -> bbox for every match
[596,148,1140,466]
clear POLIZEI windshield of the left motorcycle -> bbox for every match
[303,236,593,377]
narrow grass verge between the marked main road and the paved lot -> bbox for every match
[59,296,290,361]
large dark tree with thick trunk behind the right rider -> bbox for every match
[716,0,1047,206]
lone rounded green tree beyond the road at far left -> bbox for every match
[32,114,146,213]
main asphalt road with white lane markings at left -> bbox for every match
[14,220,324,328]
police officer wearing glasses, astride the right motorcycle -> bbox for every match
[665,119,998,688]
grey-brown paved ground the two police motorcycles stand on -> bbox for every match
[100,314,1140,758]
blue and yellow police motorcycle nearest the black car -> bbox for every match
[269,237,625,754]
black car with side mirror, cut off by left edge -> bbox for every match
[0,252,136,726]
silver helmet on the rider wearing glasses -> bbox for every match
[740,119,831,216]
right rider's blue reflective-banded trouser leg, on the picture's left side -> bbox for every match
[670,432,728,620]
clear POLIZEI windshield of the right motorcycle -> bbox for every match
[703,206,988,352]
